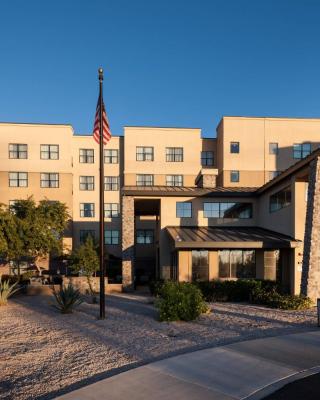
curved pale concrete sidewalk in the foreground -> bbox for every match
[58,330,320,400]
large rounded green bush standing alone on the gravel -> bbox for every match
[156,281,208,321]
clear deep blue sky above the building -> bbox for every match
[0,0,320,137]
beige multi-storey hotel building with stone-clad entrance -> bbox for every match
[0,117,320,298]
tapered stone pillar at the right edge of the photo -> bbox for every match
[301,157,320,301]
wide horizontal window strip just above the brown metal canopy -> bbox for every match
[203,202,252,219]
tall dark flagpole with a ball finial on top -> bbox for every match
[98,68,106,319]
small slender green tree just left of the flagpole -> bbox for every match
[71,235,99,300]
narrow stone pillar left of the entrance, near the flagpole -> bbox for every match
[121,196,134,290]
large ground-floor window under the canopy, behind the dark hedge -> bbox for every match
[218,250,256,279]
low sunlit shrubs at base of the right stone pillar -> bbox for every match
[251,288,312,310]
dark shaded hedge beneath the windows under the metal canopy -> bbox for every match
[197,279,277,302]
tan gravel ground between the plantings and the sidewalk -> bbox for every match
[0,295,317,400]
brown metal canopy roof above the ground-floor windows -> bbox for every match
[166,226,301,249]
